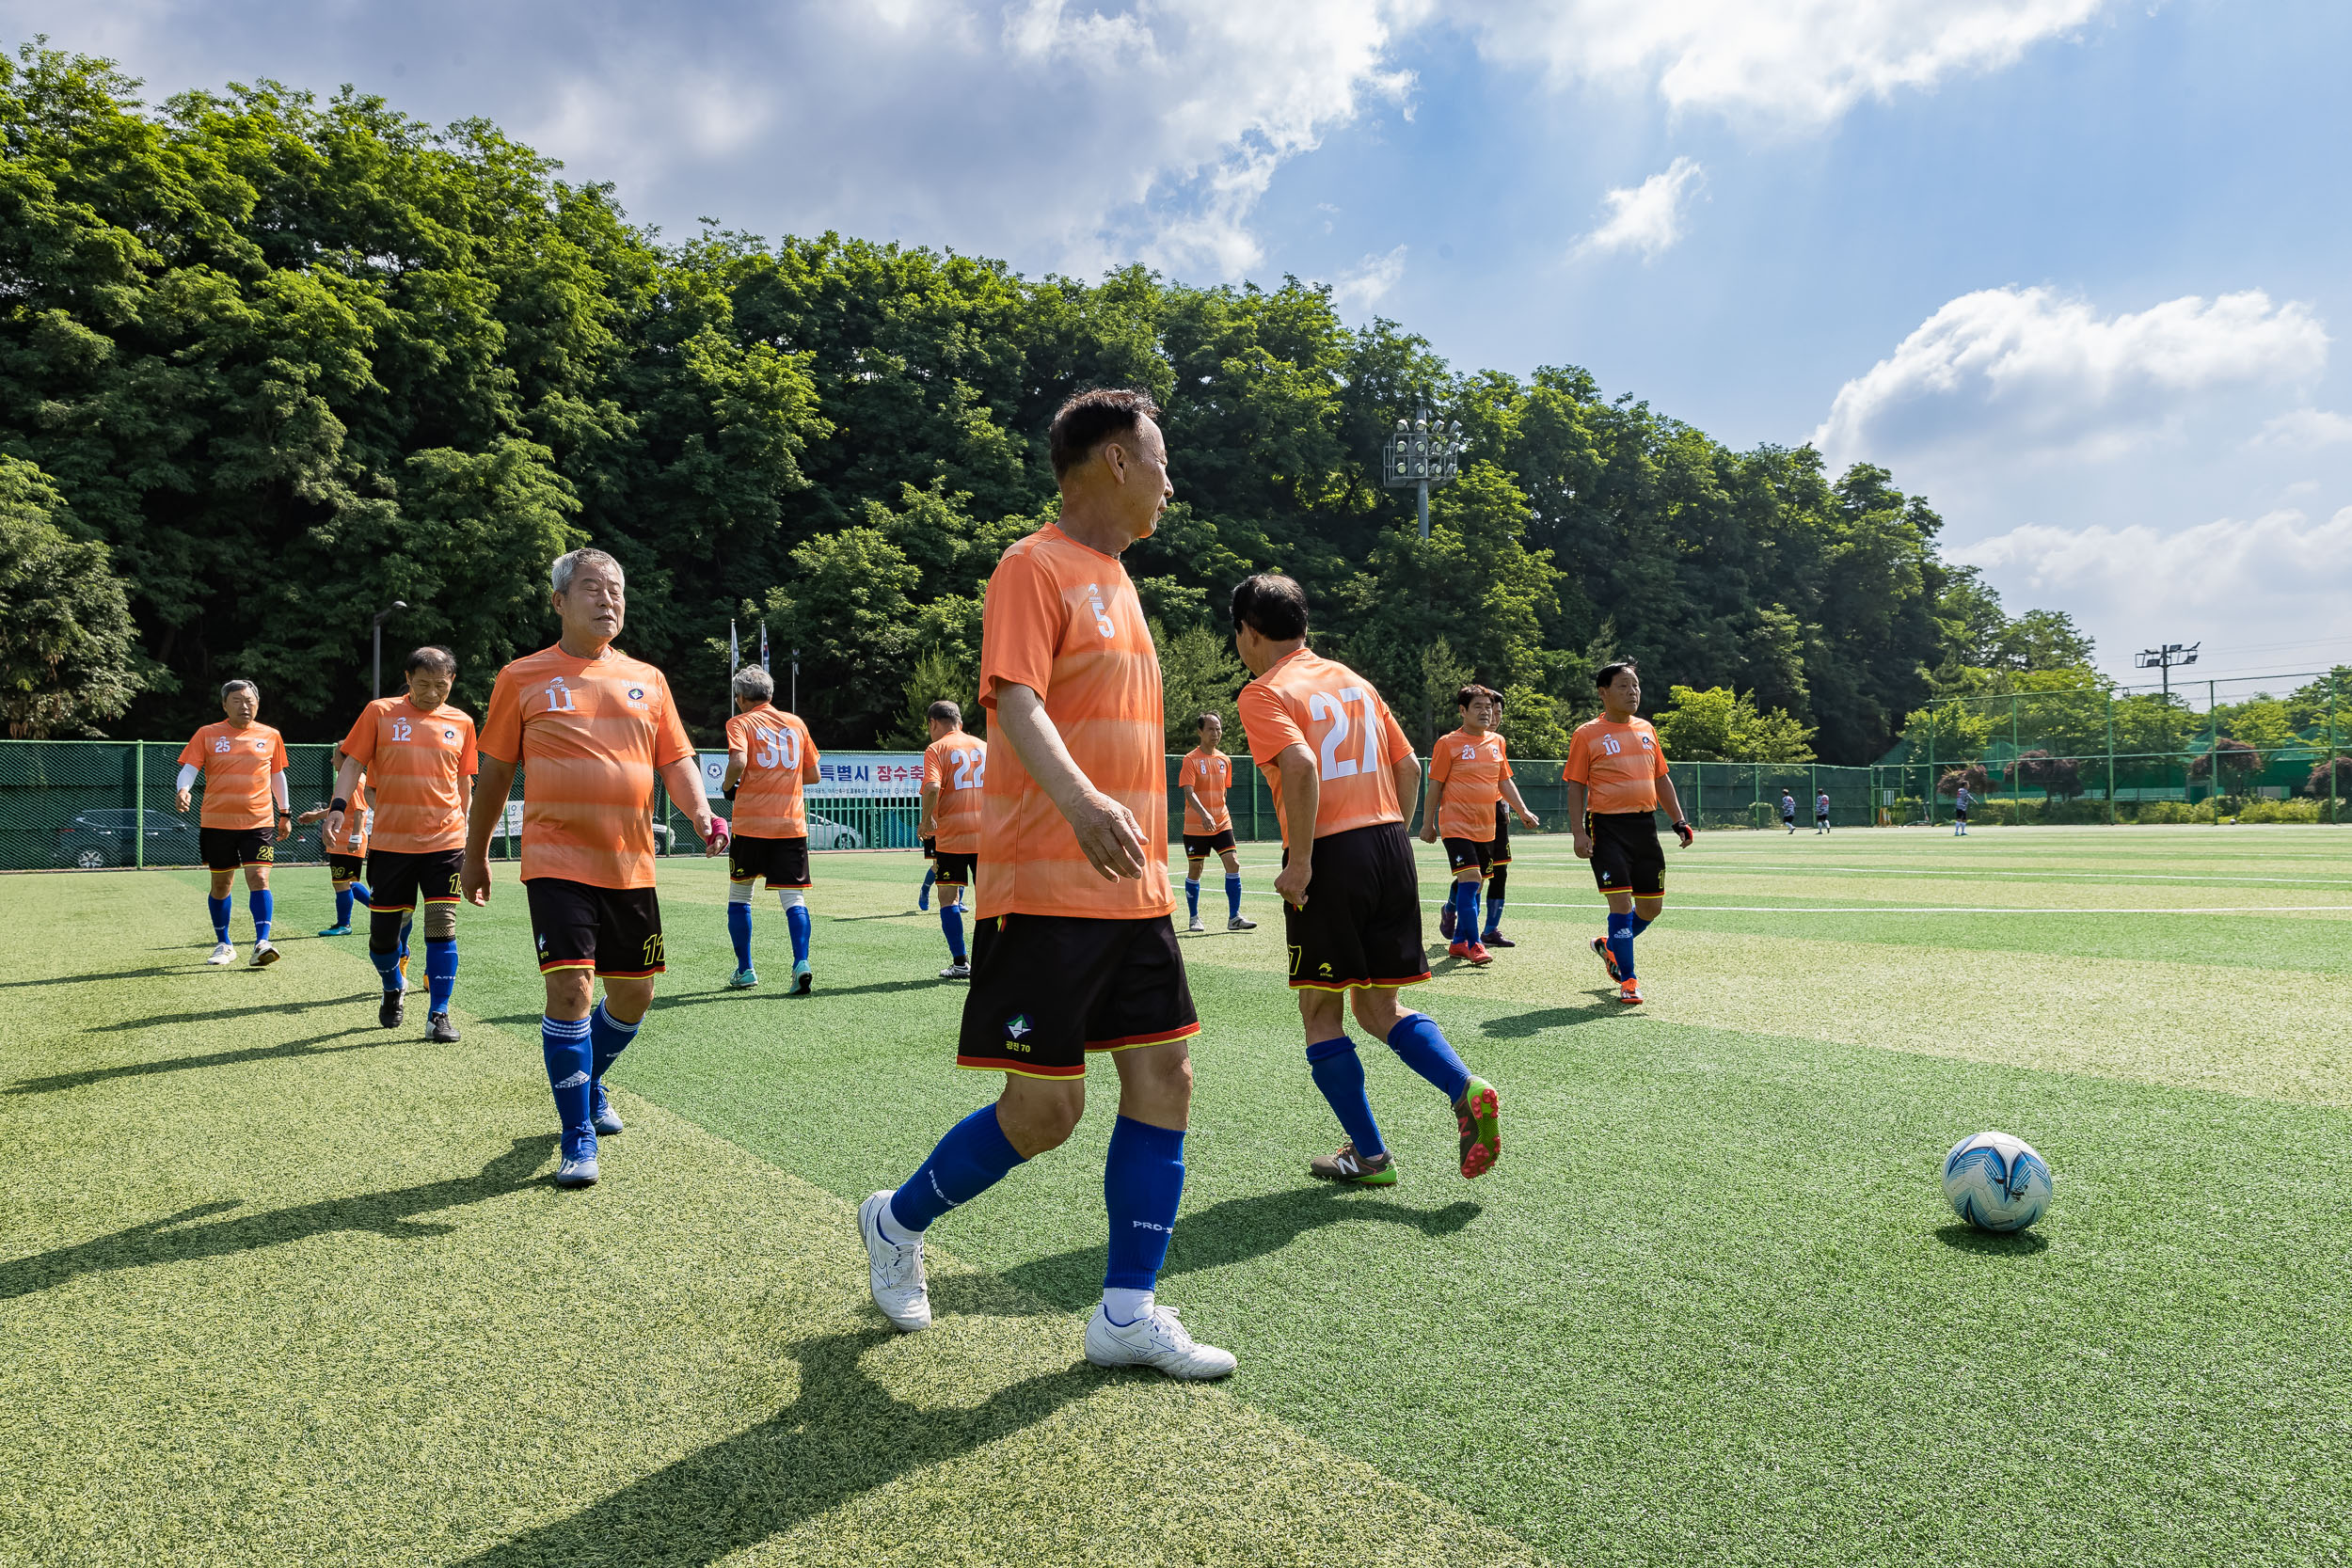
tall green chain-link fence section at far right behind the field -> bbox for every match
[1872,668,2352,825]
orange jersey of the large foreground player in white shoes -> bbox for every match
[978,524,1176,919]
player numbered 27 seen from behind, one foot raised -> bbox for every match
[1232,574,1503,1187]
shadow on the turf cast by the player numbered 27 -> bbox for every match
[931,1182,1485,1314]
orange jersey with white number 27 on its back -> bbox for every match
[1242,649,1414,842]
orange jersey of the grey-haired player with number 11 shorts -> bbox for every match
[482,644,694,889]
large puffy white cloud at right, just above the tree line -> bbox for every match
[1814,289,2328,466]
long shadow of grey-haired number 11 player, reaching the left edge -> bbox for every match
[0,1133,555,1300]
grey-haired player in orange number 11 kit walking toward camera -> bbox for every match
[453,550,727,1187]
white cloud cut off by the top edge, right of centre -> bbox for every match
[1456,0,2107,129]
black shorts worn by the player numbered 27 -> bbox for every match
[1282,823,1430,990]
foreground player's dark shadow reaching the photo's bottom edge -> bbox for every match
[459,1328,1110,1568]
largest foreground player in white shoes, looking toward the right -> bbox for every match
[859,390,1232,1378]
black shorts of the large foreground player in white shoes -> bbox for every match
[955,914,1200,1079]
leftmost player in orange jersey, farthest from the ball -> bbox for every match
[179,679,294,969]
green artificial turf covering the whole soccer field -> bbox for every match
[0,828,2352,1566]
